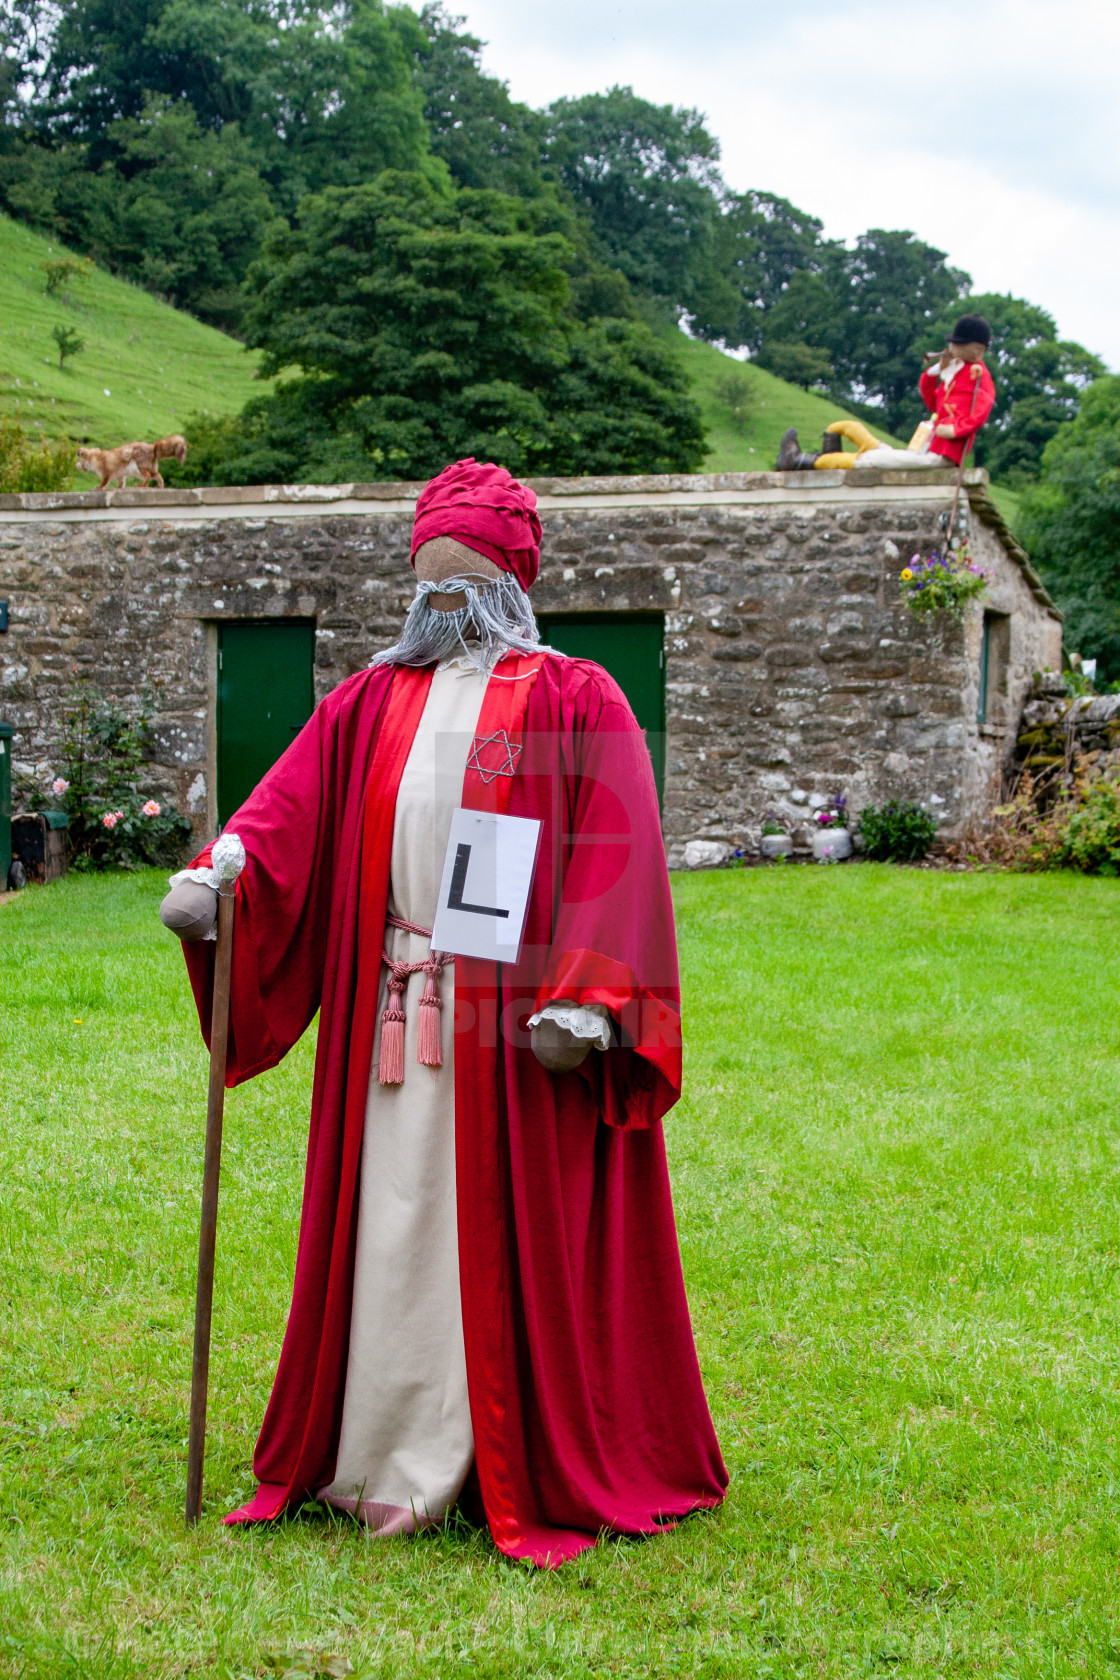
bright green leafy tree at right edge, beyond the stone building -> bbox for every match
[1021,375,1120,682]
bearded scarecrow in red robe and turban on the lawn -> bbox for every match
[163,460,727,1564]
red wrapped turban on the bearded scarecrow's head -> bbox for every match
[411,455,541,590]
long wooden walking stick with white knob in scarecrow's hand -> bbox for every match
[186,835,245,1527]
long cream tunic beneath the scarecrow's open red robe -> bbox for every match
[319,664,487,1534]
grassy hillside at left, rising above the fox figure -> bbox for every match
[0,217,270,453]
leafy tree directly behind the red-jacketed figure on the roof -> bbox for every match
[930,292,1105,484]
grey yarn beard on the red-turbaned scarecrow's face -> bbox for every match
[369,573,541,674]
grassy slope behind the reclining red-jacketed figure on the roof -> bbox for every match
[673,333,898,472]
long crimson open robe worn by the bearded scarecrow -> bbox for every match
[185,657,727,1564]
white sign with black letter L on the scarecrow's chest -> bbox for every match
[432,808,541,963]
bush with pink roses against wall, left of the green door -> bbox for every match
[52,682,190,870]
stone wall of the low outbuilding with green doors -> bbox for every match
[0,472,1061,864]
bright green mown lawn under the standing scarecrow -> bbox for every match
[0,865,1120,1680]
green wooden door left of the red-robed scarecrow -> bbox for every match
[218,618,316,827]
